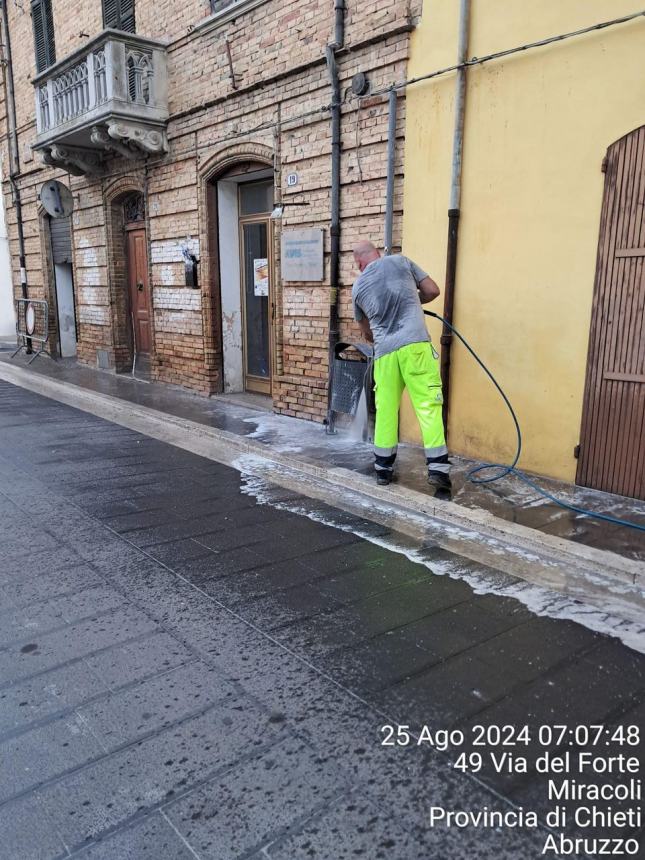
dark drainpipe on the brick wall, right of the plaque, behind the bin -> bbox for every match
[325,0,345,433]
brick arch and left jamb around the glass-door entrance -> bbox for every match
[199,141,281,392]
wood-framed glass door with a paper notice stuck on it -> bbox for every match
[240,216,272,394]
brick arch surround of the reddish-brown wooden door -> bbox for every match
[103,174,155,372]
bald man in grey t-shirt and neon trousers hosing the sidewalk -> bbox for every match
[352,242,451,490]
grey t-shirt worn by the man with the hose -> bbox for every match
[352,254,430,358]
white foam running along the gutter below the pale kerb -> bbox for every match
[231,454,645,654]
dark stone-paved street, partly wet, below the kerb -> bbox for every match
[0,377,645,860]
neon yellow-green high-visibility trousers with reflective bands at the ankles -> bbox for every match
[374,341,450,474]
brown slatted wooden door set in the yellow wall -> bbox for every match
[576,126,645,499]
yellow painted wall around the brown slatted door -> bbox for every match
[402,0,645,480]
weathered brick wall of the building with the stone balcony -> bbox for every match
[0,0,421,420]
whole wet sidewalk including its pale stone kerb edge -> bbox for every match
[0,354,645,618]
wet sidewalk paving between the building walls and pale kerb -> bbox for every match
[0,353,645,561]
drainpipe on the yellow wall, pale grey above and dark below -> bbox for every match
[441,0,470,428]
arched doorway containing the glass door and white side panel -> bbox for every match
[208,160,276,395]
